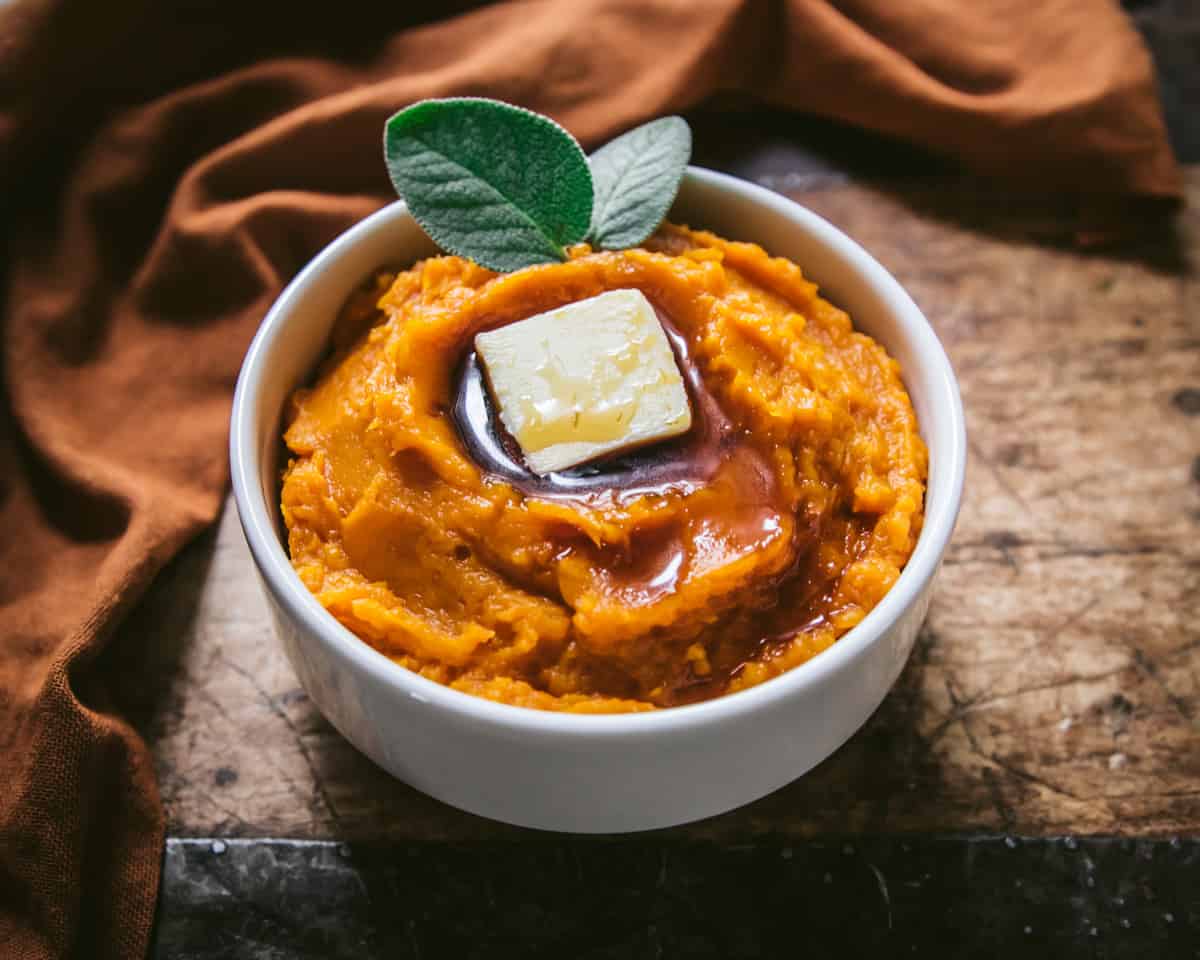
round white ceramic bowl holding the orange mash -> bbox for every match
[230,168,966,833]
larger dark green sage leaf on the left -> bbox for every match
[384,97,592,271]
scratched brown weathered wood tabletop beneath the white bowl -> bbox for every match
[115,166,1200,840]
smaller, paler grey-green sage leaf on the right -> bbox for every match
[588,116,691,250]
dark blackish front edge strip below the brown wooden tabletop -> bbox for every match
[152,833,1200,960]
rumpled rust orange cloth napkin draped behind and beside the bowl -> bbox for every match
[0,0,1180,958]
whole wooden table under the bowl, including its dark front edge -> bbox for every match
[113,110,1200,960]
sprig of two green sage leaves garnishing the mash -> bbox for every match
[384,97,691,272]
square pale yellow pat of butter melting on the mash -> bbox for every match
[475,290,691,474]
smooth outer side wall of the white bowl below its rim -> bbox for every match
[268,566,931,833]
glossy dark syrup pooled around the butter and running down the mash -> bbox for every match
[452,300,859,706]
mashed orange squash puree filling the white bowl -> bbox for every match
[282,226,926,713]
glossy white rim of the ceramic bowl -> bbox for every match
[229,167,966,738]
